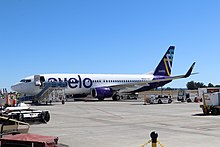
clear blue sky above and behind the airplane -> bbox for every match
[0,0,220,88]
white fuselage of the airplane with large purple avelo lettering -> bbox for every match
[12,74,154,95]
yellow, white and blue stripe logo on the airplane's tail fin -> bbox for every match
[163,49,174,76]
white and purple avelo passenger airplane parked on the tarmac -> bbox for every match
[11,46,195,100]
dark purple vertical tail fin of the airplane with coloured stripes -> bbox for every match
[153,46,175,76]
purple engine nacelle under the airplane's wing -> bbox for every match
[91,87,113,100]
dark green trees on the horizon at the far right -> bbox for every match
[186,81,220,90]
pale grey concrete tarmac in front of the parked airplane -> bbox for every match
[29,100,220,147]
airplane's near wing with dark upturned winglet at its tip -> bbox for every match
[108,62,197,92]
